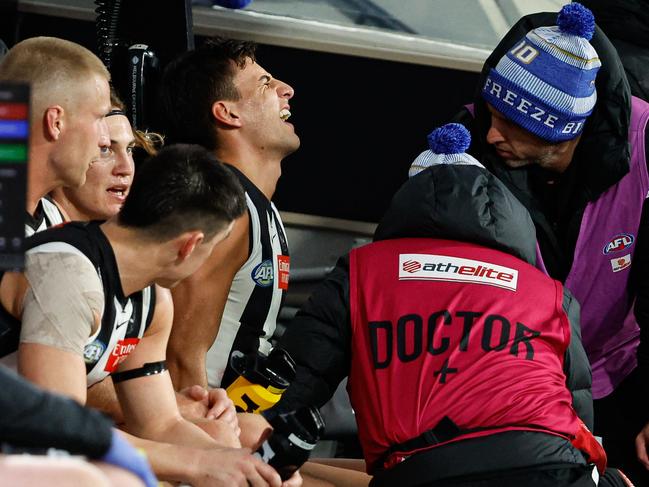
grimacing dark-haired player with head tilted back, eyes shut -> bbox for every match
[161,39,300,388]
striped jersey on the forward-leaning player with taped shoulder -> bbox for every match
[19,222,155,387]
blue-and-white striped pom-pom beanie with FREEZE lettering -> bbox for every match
[482,3,601,143]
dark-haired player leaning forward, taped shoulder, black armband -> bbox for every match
[1,145,296,487]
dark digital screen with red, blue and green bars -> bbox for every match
[0,82,29,271]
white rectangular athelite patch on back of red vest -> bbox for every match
[399,254,518,291]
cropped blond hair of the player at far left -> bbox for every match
[0,37,110,116]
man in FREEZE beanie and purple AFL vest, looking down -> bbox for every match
[456,3,649,485]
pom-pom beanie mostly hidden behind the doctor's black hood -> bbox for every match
[408,123,484,177]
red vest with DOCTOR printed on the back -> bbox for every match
[348,239,579,472]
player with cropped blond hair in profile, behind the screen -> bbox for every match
[0,37,110,235]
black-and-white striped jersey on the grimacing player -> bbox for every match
[206,166,290,387]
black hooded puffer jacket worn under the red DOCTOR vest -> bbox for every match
[279,165,593,427]
